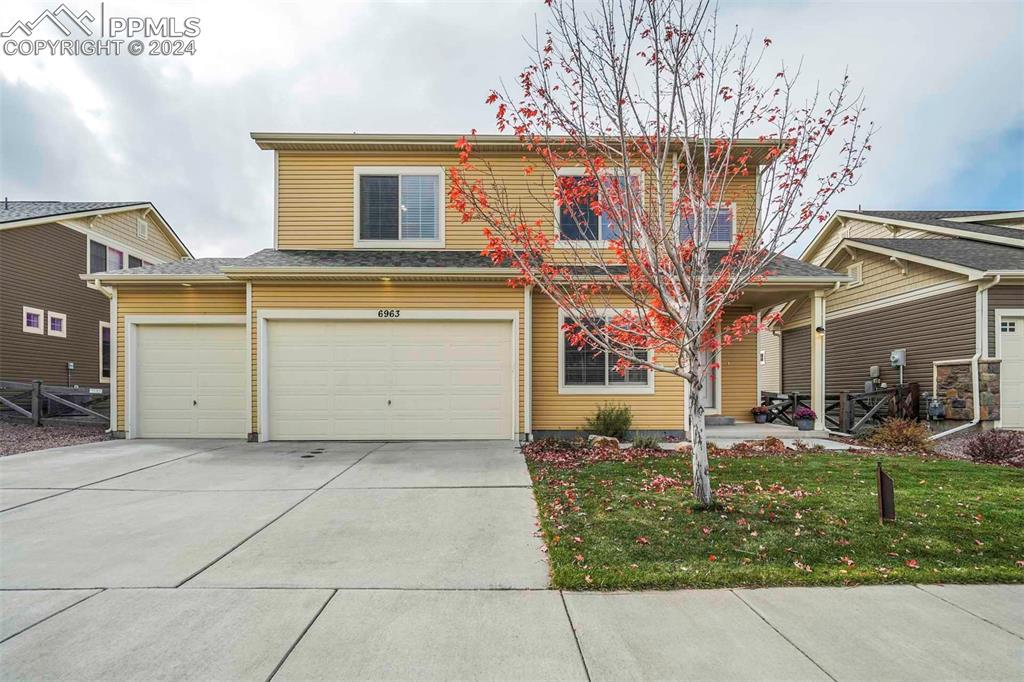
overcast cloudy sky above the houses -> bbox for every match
[0,0,1024,256]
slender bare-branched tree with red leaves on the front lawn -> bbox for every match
[449,0,872,506]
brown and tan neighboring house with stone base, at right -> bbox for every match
[776,211,1024,427]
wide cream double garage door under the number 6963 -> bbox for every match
[265,319,514,440]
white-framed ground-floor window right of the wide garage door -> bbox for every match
[559,317,653,393]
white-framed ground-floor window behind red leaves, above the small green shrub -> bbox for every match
[558,310,654,394]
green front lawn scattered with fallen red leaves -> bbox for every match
[529,453,1024,589]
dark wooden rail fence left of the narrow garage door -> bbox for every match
[0,381,111,426]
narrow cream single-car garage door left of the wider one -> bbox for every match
[132,325,249,438]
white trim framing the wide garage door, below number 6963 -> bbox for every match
[256,307,520,442]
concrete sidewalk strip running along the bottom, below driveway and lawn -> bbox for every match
[0,586,1024,680]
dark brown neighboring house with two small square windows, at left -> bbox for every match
[0,201,191,388]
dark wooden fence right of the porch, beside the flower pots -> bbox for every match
[761,384,921,434]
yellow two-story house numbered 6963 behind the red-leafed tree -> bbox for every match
[83,133,845,440]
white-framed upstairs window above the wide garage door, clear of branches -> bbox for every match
[353,166,444,249]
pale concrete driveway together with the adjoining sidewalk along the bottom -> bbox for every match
[0,440,1024,680]
